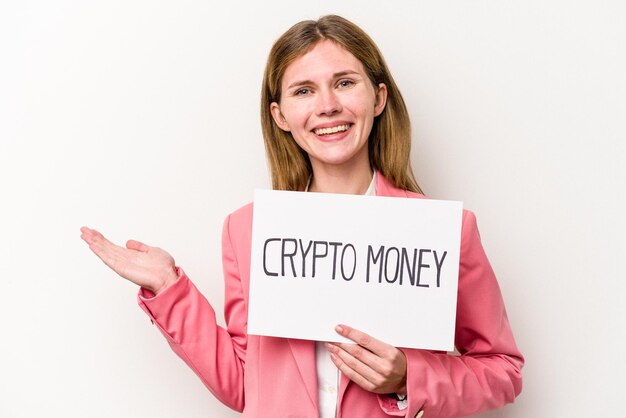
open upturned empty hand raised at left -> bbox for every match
[80,226,178,295]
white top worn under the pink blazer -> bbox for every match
[312,172,376,418]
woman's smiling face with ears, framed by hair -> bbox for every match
[270,40,387,178]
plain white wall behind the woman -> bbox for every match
[0,0,626,418]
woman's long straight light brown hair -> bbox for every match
[261,15,421,193]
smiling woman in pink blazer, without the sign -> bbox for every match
[82,16,523,418]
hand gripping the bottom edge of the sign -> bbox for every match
[326,325,406,395]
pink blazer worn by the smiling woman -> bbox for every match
[139,171,524,418]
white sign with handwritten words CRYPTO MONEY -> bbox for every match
[248,190,462,351]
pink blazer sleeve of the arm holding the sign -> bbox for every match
[380,211,524,418]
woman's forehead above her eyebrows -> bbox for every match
[281,40,366,88]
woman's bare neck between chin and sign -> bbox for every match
[309,162,373,195]
